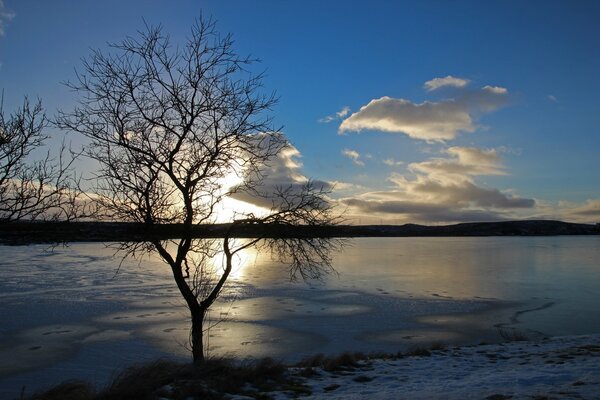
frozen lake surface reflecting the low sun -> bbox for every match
[0,236,600,398]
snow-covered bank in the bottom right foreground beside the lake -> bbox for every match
[269,335,600,400]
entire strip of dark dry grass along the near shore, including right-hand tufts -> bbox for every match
[22,345,454,400]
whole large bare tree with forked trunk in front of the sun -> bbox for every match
[58,19,342,362]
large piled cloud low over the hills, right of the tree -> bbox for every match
[341,146,536,222]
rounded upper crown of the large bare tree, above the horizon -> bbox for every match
[59,21,284,223]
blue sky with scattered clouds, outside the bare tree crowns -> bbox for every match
[0,0,600,223]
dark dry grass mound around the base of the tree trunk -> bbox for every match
[23,358,309,400]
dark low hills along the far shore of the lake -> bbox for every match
[0,220,600,244]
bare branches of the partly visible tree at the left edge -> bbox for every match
[0,98,80,222]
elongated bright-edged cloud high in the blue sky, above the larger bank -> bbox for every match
[339,78,508,142]
